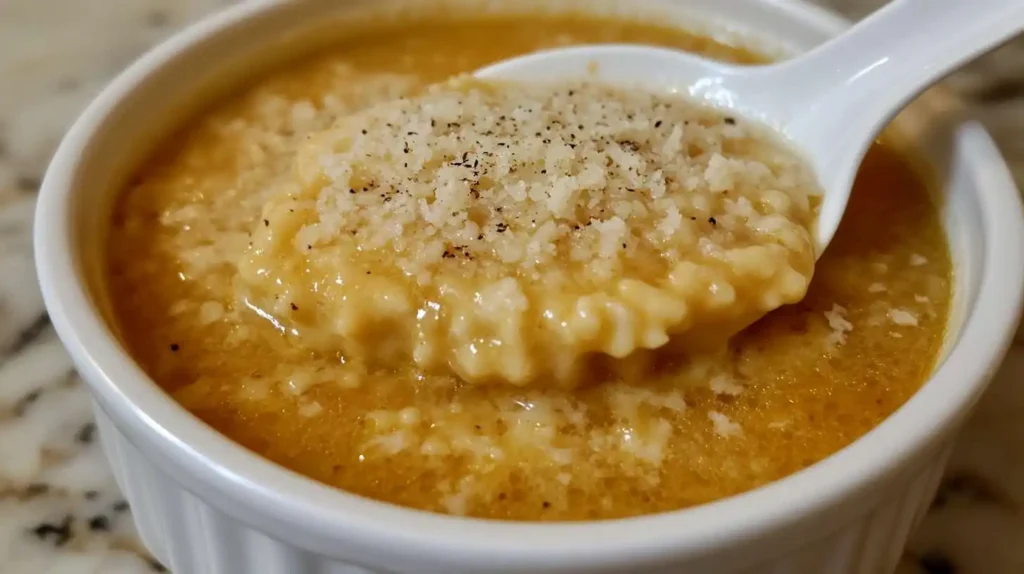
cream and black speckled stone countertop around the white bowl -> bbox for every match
[0,0,1024,574]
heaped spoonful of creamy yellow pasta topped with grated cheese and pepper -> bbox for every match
[239,78,818,385]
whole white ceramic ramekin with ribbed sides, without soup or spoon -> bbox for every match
[35,0,1024,574]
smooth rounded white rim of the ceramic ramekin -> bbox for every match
[34,0,1024,567]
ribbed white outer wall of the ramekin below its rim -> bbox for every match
[94,406,951,574]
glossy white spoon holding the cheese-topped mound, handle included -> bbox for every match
[476,0,1024,255]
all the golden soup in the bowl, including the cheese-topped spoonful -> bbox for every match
[108,13,951,520]
